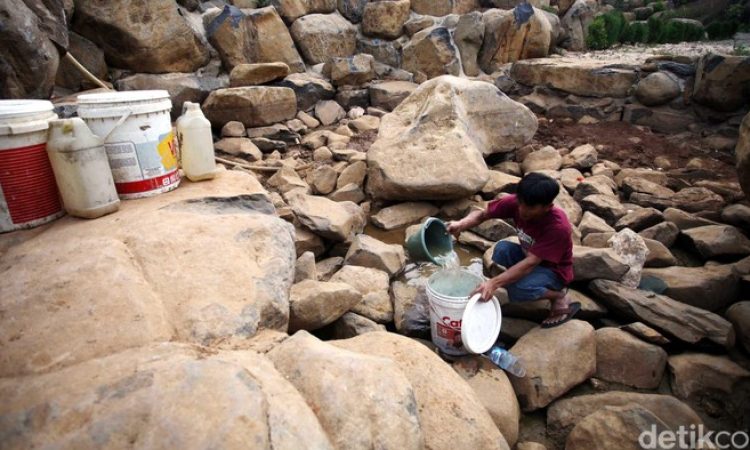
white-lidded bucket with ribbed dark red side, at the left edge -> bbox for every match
[0,100,65,232]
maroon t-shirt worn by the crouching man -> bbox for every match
[486,195,573,285]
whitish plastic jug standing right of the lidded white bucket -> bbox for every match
[177,102,216,181]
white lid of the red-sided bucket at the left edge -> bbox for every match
[0,100,57,136]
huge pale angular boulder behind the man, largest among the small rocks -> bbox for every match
[367,76,537,200]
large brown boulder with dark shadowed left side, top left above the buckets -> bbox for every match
[73,0,209,73]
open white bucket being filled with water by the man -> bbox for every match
[426,270,483,356]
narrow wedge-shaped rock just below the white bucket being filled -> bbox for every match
[453,356,521,446]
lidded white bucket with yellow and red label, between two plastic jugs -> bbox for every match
[78,91,180,199]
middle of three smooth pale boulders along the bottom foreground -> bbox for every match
[267,331,425,449]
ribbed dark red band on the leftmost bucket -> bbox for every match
[0,144,62,225]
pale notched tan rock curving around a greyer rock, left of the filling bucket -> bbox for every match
[331,265,393,323]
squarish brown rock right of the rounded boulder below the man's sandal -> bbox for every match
[595,327,667,389]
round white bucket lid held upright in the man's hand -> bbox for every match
[461,294,503,354]
